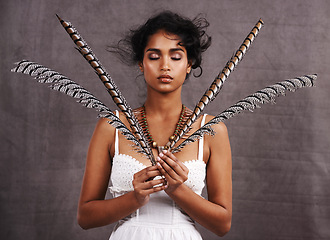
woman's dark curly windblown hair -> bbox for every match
[109,11,211,77]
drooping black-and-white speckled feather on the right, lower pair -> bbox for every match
[172,74,317,153]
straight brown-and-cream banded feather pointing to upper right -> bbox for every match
[170,19,263,148]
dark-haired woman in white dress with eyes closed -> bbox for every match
[78,12,232,239]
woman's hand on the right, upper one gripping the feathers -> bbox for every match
[157,150,189,193]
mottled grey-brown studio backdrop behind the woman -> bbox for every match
[0,0,330,240]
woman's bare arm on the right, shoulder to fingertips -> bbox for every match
[160,120,232,236]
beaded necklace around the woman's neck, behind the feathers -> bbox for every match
[134,104,192,152]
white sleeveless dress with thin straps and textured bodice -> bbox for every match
[110,113,206,240]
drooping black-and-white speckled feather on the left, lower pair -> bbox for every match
[11,60,146,154]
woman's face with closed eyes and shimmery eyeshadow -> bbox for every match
[139,30,191,93]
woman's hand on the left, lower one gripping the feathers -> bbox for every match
[132,166,166,206]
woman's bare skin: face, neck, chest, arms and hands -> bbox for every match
[78,30,232,236]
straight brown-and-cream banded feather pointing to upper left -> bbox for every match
[56,15,156,165]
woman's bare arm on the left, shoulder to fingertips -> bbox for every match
[77,119,165,229]
